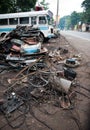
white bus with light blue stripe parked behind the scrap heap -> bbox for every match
[0,10,54,39]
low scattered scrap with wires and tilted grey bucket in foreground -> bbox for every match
[0,46,83,128]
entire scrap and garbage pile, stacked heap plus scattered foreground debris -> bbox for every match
[0,29,88,129]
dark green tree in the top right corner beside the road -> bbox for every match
[82,0,90,22]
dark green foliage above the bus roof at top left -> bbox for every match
[0,0,37,14]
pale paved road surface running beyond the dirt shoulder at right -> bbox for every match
[61,31,90,61]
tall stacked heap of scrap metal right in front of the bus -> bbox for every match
[0,26,47,67]
